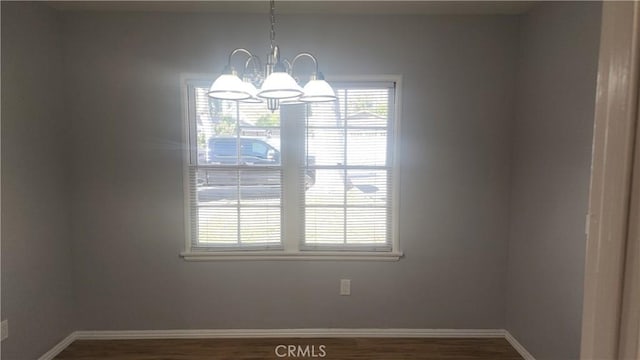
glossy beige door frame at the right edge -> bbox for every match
[581,1,640,359]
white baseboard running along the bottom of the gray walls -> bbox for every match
[38,329,535,360]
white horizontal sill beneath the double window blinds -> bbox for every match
[180,251,403,261]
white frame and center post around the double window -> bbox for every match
[180,74,403,261]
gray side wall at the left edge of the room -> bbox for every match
[2,2,75,360]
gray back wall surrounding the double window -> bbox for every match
[64,13,518,329]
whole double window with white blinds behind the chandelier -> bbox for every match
[183,80,401,260]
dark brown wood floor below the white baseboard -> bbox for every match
[55,338,522,360]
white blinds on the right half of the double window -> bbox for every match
[302,82,395,251]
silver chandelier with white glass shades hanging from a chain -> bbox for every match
[207,0,337,111]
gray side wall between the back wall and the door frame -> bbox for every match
[507,2,601,360]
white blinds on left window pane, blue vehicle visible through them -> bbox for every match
[188,83,282,250]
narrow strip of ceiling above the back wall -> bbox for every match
[47,0,535,15]
